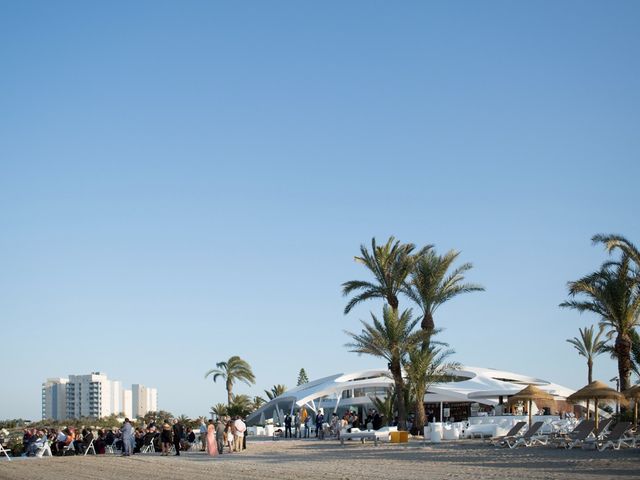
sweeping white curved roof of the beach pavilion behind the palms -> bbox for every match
[247,366,574,422]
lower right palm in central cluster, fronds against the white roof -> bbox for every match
[404,340,460,434]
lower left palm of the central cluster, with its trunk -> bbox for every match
[345,305,424,428]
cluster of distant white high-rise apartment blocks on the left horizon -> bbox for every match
[42,372,157,420]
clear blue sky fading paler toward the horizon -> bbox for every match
[0,0,640,418]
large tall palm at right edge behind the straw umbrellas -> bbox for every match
[560,255,640,396]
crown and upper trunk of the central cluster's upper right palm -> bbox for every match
[404,249,484,332]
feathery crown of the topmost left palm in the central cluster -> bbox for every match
[342,237,431,315]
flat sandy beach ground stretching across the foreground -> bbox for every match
[0,440,640,480]
